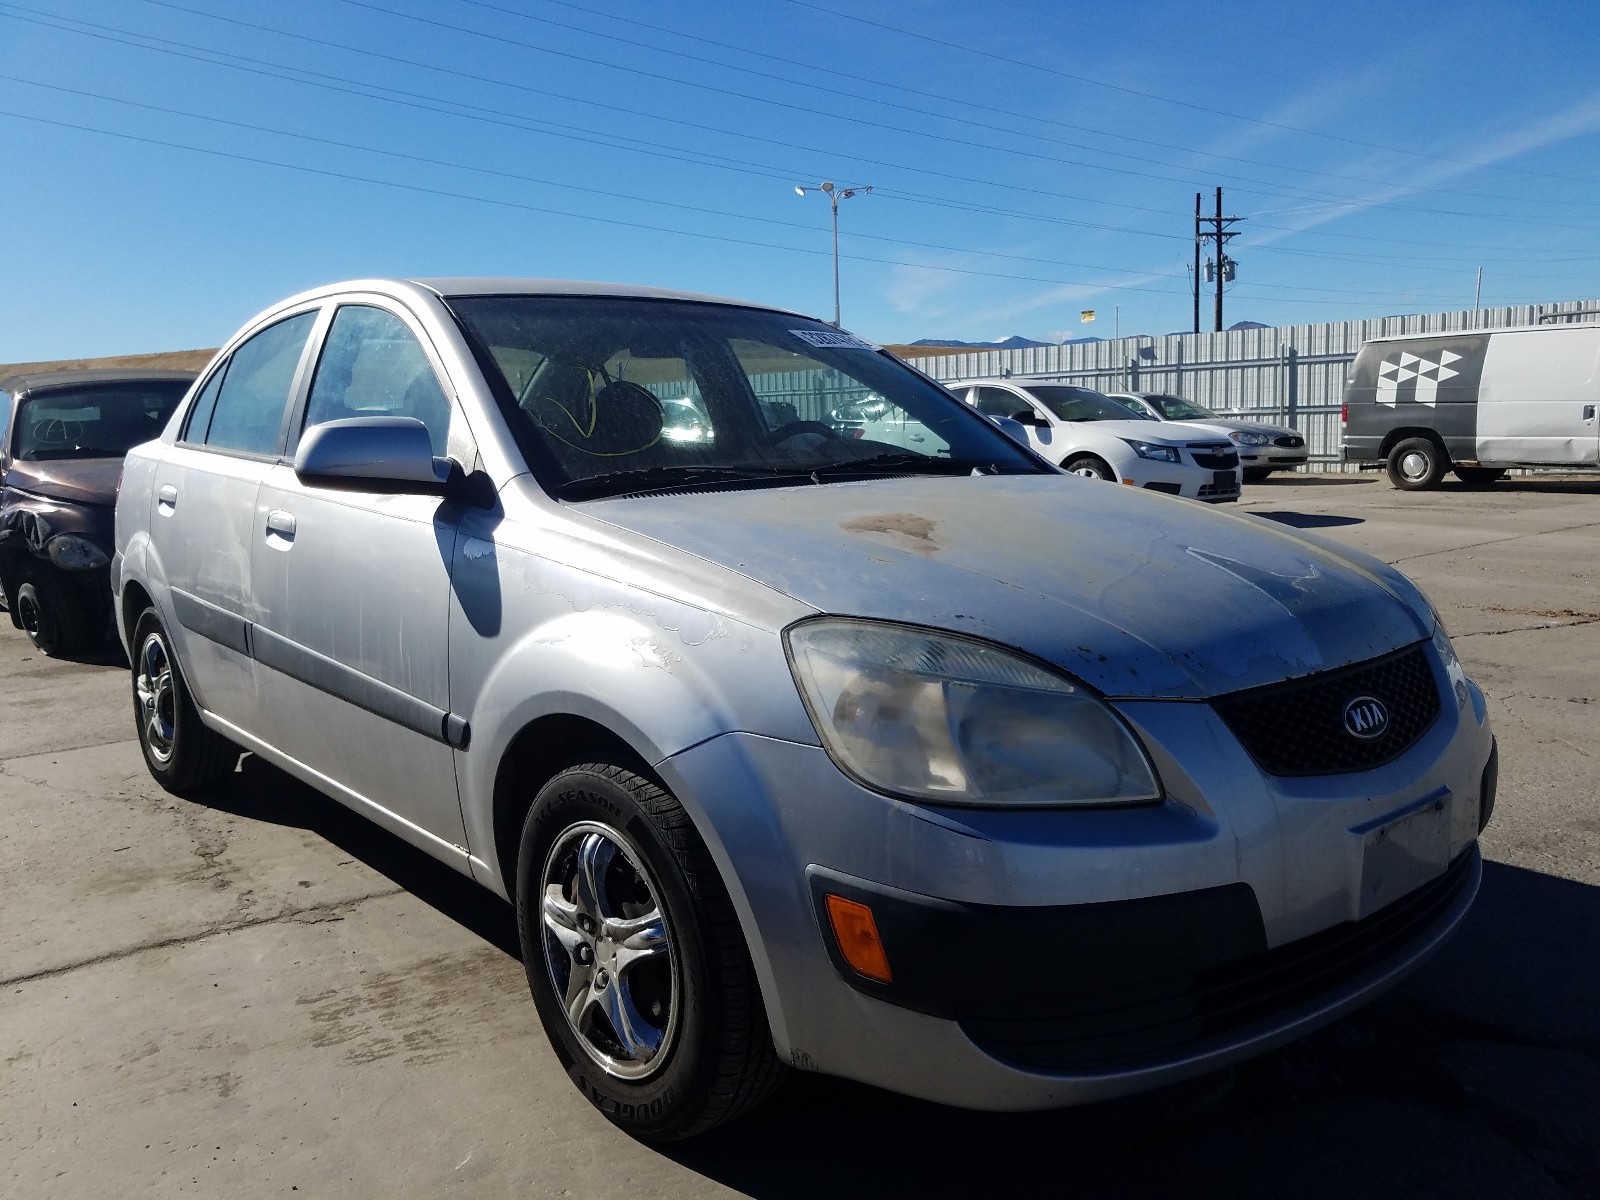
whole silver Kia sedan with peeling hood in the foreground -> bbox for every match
[112,280,1496,1139]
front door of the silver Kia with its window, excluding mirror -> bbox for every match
[250,298,477,859]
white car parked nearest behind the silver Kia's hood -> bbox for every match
[944,379,1238,504]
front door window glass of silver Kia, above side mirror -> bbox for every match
[306,304,451,456]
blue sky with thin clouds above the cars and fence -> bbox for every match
[0,0,1600,362]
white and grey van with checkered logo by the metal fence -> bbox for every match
[1339,323,1600,491]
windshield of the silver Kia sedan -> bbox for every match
[448,296,1040,499]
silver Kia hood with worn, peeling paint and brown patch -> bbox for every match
[582,473,1432,699]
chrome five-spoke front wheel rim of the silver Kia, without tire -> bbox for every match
[539,821,682,1082]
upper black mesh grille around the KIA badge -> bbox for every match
[1213,646,1438,774]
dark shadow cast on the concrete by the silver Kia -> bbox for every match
[181,754,1600,1200]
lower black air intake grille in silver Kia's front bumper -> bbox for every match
[962,850,1477,1072]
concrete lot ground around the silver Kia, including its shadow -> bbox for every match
[0,475,1600,1200]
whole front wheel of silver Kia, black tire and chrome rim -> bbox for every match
[517,763,784,1141]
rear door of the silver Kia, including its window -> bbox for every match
[149,309,317,733]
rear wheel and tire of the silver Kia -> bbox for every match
[133,608,238,795]
